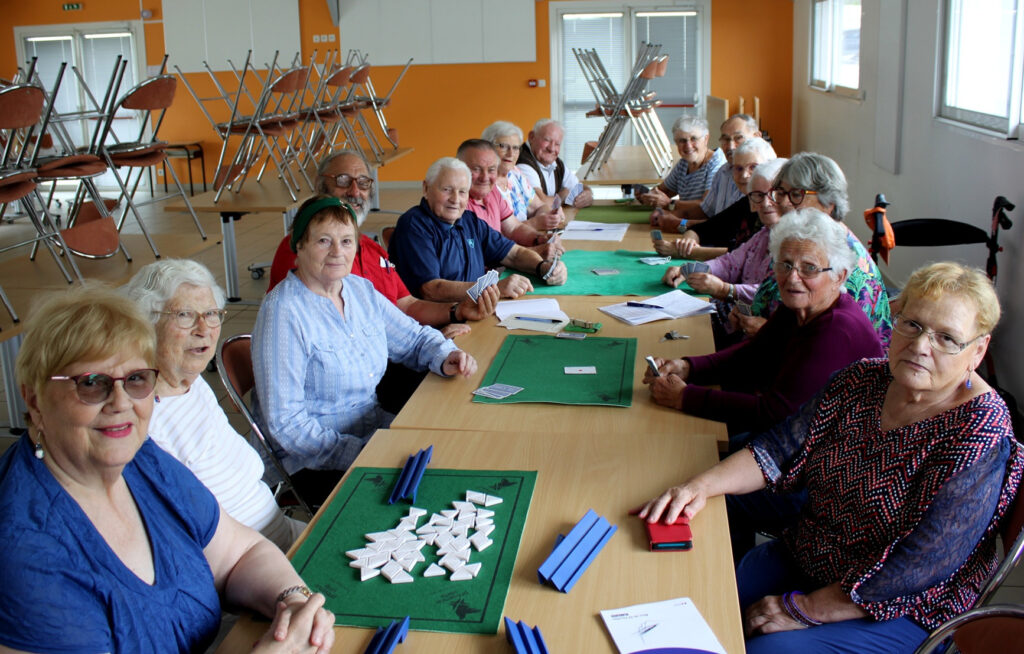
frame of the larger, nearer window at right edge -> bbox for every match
[935,0,1024,139]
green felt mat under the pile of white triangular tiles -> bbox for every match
[292,468,537,634]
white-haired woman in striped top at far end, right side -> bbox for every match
[640,116,725,209]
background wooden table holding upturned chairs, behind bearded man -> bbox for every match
[167,147,413,302]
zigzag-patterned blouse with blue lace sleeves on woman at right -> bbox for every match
[748,359,1024,630]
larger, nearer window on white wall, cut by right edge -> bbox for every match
[938,0,1024,137]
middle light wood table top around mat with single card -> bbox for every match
[391,296,728,443]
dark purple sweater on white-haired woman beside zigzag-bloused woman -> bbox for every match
[680,293,885,432]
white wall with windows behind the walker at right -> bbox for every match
[792,0,1024,407]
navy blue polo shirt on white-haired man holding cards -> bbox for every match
[387,199,515,298]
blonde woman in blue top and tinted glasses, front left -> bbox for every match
[0,288,334,653]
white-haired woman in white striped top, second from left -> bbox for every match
[121,259,305,551]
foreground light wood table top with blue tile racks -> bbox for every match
[217,429,743,654]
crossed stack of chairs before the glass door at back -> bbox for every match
[572,43,673,176]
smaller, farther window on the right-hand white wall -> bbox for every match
[811,0,860,96]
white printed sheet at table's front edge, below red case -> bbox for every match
[601,598,725,654]
